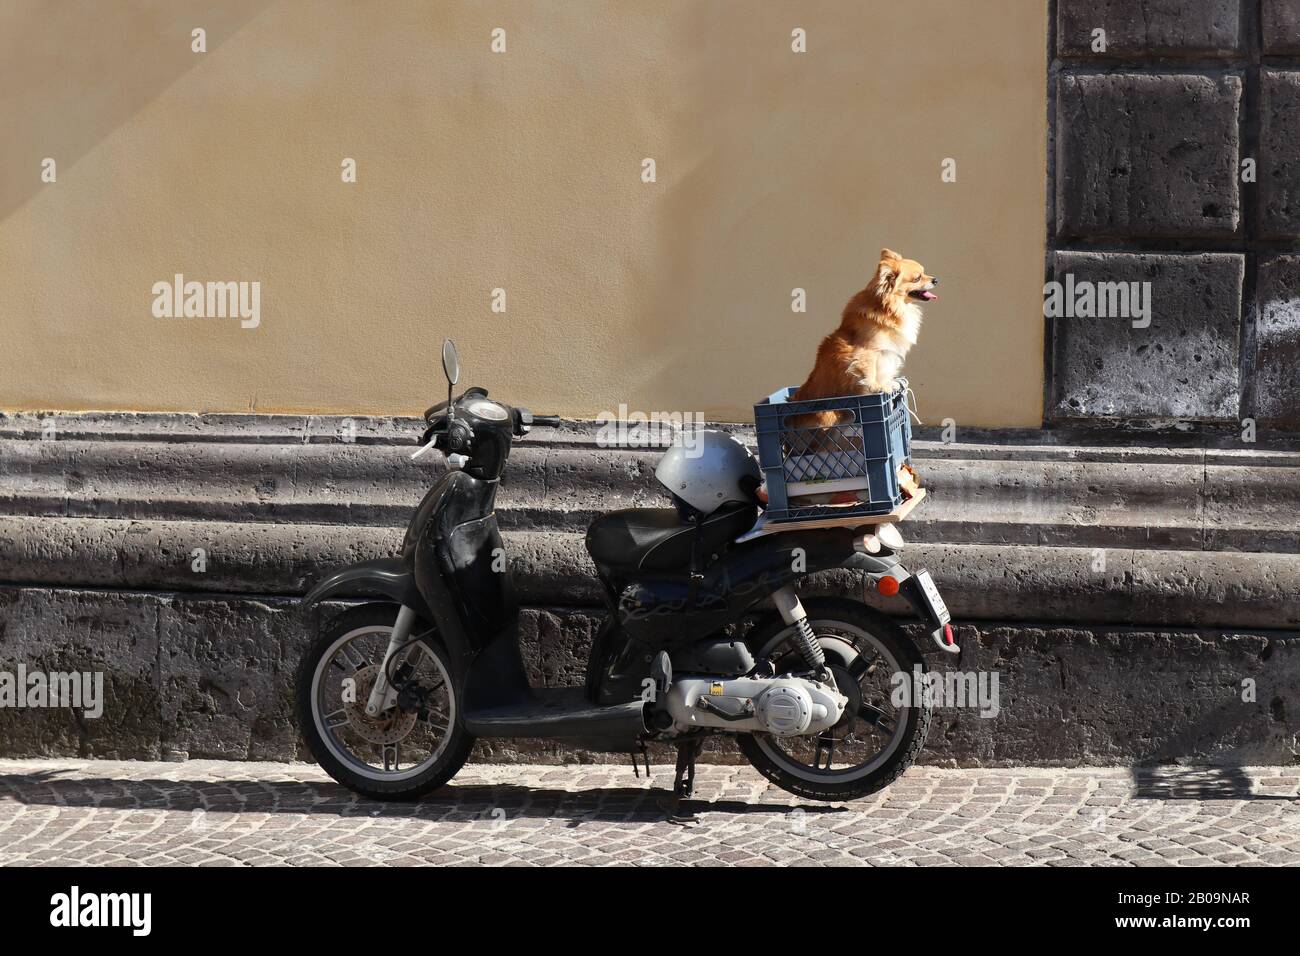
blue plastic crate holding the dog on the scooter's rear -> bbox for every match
[754,380,911,522]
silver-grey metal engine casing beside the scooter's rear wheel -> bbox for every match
[666,676,849,737]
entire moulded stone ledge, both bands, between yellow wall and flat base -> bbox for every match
[0,415,1300,627]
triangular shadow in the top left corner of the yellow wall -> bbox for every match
[0,0,276,220]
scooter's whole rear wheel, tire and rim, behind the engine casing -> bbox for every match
[737,598,931,801]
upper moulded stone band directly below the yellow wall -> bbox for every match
[0,424,1300,551]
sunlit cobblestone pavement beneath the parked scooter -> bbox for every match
[0,761,1300,866]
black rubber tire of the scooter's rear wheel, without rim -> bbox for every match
[737,598,931,801]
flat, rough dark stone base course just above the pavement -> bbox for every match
[0,587,1300,766]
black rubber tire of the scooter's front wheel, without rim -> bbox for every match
[295,604,475,800]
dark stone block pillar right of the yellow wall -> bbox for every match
[1047,0,1300,432]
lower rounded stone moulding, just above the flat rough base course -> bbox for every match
[0,516,1300,628]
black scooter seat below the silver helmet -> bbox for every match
[586,503,758,571]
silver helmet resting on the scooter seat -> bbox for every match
[654,431,763,515]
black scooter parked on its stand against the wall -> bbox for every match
[296,341,957,800]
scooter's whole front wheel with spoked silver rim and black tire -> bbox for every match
[296,604,475,800]
